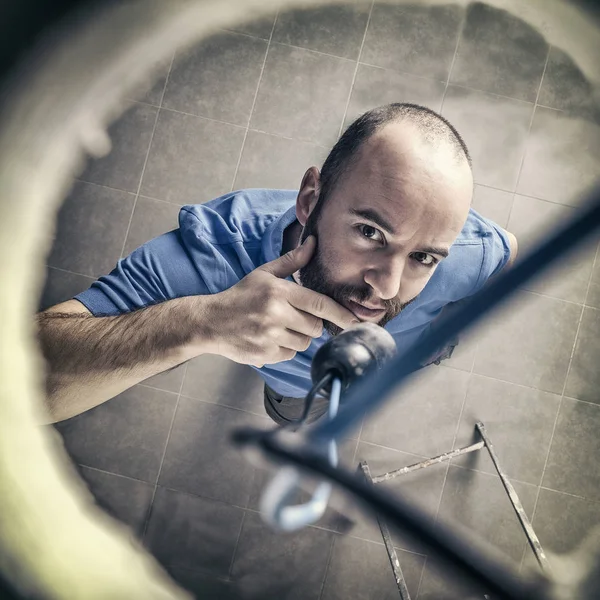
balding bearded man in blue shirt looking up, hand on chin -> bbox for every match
[38,104,517,424]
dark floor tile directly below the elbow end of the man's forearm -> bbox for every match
[55,386,177,483]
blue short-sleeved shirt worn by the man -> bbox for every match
[75,189,510,397]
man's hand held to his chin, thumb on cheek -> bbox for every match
[202,236,359,367]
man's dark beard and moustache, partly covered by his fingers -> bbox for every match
[298,200,417,336]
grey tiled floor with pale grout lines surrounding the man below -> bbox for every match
[41,1,600,600]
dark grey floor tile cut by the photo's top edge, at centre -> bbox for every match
[273,0,369,60]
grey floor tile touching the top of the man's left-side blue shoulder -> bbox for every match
[141,109,244,204]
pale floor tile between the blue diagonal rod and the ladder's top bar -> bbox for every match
[360,367,469,457]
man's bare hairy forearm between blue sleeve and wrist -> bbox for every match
[37,296,210,422]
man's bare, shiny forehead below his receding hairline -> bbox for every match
[334,125,473,237]
